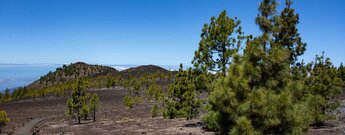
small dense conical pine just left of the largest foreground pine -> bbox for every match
[163,64,201,120]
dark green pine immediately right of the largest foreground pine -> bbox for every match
[306,53,341,125]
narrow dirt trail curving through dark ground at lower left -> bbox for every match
[13,118,45,135]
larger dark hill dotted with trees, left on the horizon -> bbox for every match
[28,62,118,88]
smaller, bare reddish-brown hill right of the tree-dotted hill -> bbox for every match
[121,65,169,73]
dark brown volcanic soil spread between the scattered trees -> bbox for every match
[0,87,345,135]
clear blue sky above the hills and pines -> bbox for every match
[0,0,345,65]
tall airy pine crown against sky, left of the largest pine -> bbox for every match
[192,11,243,76]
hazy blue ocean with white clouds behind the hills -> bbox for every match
[0,64,178,91]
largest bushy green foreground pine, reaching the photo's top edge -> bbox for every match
[203,0,312,134]
